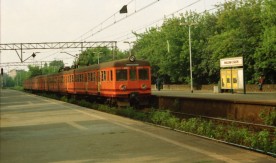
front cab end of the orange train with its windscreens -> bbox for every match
[100,60,151,106]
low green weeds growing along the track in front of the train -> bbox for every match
[149,110,276,153]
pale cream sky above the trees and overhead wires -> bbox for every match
[0,0,225,72]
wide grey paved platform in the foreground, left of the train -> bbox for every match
[0,90,276,163]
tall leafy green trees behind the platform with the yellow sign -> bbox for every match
[133,0,276,84]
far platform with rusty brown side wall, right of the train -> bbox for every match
[152,90,276,124]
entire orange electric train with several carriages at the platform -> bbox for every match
[24,57,151,106]
